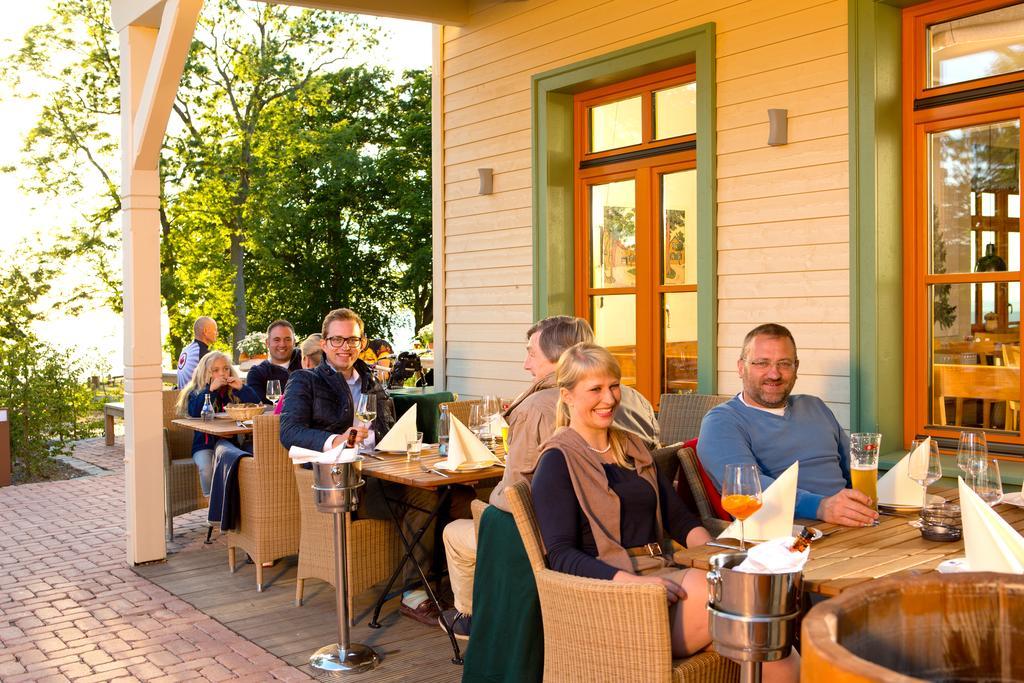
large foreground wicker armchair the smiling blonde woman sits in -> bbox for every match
[508,481,739,683]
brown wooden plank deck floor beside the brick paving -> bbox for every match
[135,546,462,683]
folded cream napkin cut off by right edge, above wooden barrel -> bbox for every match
[957,477,1024,573]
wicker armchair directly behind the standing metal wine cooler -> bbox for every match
[293,465,401,622]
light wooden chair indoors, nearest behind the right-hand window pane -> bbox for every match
[932,364,1021,431]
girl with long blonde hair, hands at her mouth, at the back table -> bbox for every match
[178,351,259,498]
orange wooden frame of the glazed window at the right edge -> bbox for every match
[902,0,1024,446]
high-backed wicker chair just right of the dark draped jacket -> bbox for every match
[224,415,299,591]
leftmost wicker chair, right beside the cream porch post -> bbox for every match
[163,389,204,541]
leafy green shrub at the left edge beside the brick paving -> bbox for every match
[0,335,91,478]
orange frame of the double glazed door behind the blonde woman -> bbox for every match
[573,66,697,409]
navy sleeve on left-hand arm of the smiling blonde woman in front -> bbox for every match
[531,449,618,580]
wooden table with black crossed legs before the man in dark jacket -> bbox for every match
[362,441,505,664]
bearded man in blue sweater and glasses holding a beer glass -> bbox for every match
[697,324,879,526]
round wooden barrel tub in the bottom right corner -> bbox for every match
[801,572,1024,683]
